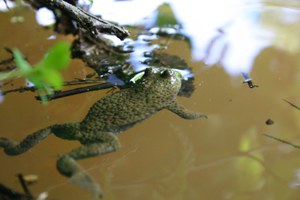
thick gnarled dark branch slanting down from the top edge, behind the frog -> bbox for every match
[45,0,129,40]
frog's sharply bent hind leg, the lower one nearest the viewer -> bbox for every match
[57,133,120,198]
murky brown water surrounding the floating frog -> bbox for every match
[0,1,300,200]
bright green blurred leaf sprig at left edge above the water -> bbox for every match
[0,42,71,103]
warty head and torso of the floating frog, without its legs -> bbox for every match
[81,68,181,133]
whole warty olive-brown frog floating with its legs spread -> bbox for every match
[0,68,207,199]
